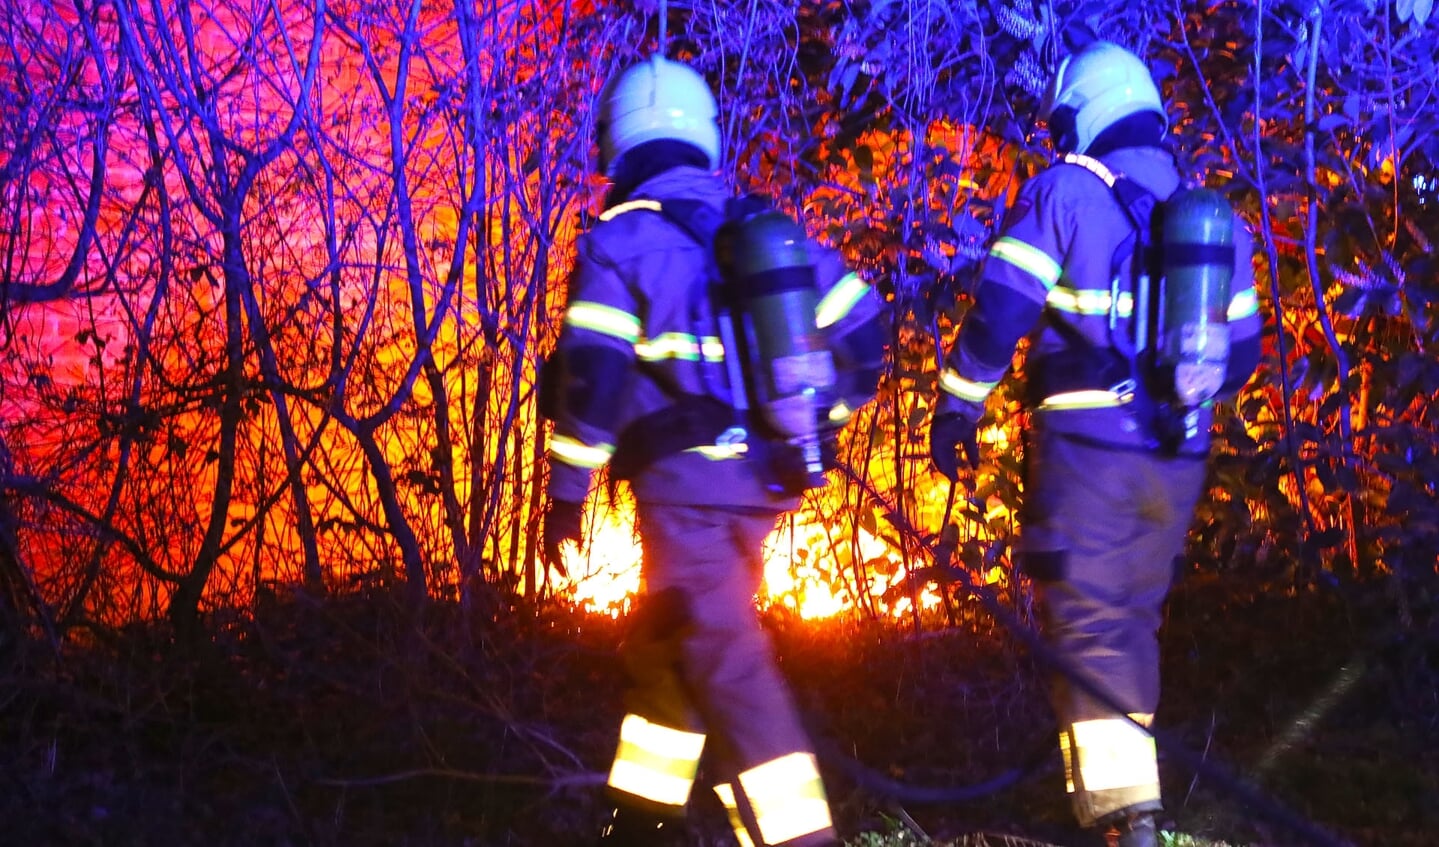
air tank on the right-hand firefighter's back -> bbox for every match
[1157,188,1235,408]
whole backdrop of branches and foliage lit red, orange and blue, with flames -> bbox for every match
[0,0,1439,624]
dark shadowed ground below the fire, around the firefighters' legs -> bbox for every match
[0,578,1439,847]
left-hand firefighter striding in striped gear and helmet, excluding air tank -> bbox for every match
[541,56,884,847]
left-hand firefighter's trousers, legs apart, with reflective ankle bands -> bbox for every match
[609,500,836,847]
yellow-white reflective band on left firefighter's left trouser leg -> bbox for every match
[609,715,705,811]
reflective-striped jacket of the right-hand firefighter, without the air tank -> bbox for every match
[940,147,1261,456]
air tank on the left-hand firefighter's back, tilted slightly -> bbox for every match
[715,210,837,493]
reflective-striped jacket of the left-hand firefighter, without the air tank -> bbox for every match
[547,167,882,511]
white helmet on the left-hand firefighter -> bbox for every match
[599,53,720,177]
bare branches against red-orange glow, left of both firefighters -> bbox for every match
[4,3,603,620]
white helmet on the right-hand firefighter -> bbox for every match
[1039,42,1168,152]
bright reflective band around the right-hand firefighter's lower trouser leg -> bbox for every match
[1059,715,1160,827]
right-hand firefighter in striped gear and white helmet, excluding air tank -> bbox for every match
[931,42,1261,847]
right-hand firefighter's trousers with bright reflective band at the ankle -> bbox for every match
[1020,426,1204,827]
